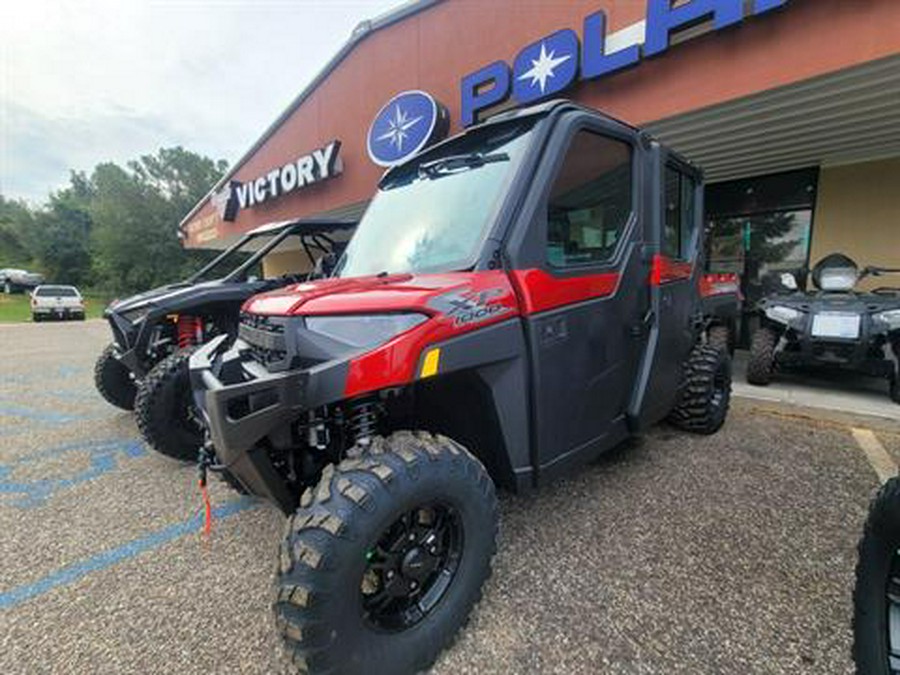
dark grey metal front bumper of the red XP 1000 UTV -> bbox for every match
[190,336,348,512]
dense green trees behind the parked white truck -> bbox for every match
[0,147,226,294]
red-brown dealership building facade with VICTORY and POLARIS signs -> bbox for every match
[181,0,900,312]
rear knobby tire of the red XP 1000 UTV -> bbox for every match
[669,345,731,434]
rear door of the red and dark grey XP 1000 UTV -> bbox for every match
[629,151,703,429]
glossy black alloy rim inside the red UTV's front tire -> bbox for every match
[360,504,464,630]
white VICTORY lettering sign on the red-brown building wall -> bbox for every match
[212,140,343,221]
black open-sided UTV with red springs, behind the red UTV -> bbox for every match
[94,220,356,461]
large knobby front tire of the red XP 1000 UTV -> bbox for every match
[273,431,498,675]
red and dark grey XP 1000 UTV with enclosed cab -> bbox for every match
[190,101,731,674]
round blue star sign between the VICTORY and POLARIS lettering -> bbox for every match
[366,90,450,167]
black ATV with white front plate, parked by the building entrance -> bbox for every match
[747,253,900,403]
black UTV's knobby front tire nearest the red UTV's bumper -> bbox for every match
[134,349,204,462]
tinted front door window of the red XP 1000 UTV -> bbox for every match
[547,131,633,267]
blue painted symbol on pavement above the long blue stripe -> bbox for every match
[0,439,146,509]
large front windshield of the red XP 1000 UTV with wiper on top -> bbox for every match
[336,119,534,277]
